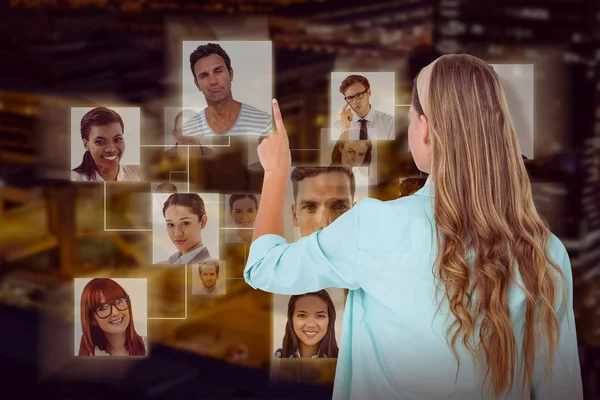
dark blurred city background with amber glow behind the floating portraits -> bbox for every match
[0,0,600,400]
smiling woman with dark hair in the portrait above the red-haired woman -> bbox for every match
[71,107,140,181]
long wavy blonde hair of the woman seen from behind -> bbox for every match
[413,54,566,396]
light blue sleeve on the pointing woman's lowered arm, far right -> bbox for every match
[532,250,583,400]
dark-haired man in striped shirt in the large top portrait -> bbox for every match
[183,43,272,136]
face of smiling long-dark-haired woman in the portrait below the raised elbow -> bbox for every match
[292,296,329,346]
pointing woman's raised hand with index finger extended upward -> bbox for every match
[258,100,292,177]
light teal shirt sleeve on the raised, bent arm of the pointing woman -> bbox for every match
[244,201,364,294]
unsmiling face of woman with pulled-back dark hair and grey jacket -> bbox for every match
[165,205,207,253]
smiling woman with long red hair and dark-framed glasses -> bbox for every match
[79,278,147,356]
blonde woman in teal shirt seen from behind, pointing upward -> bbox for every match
[244,54,582,400]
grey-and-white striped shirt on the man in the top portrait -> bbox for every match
[183,103,273,136]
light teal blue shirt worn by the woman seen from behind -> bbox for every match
[244,182,583,400]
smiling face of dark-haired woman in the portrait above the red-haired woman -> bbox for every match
[83,122,125,170]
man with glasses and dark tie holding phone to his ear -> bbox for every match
[335,75,396,140]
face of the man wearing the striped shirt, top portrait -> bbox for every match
[194,54,233,102]
